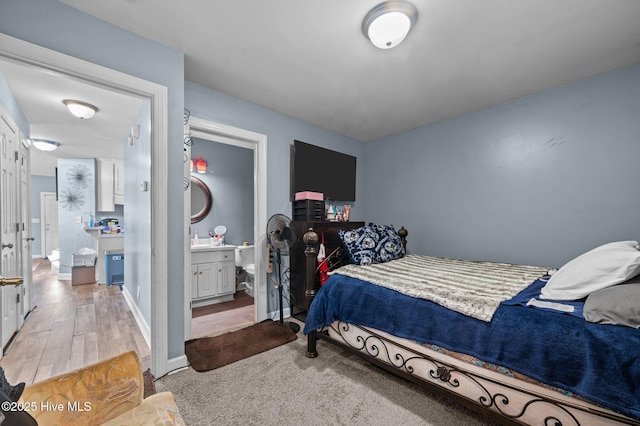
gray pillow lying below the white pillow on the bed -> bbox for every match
[583,276,640,328]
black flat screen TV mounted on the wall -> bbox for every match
[291,140,356,201]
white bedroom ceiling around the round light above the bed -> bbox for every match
[61,0,640,141]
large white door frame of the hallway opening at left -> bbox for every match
[0,33,172,377]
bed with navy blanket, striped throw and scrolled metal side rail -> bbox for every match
[303,224,640,426]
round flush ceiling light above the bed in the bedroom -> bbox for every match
[362,1,418,49]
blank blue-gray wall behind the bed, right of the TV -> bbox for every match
[365,65,640,267]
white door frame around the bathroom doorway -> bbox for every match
[184,116,267,340]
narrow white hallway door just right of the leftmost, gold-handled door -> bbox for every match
[18,138,33,322]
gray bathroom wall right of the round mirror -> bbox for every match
[191,138,254,245]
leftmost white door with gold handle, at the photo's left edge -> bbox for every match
[0,115,21,347]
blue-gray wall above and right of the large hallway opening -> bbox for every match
[0,0,184,358]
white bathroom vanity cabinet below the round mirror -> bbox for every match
[191,245,236,308]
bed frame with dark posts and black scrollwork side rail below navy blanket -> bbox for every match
[303,227,640,426]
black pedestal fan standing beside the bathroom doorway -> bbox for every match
[267,214,300,333]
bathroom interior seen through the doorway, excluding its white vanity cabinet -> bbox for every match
[189,138,255,338]
